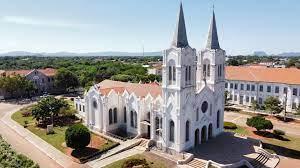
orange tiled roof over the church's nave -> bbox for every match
[98,80,162,97]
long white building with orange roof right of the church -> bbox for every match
[225,66,300,112]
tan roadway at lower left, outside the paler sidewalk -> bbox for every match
[0,103,61,168]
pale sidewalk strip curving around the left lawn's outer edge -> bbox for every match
[1,105,87,168]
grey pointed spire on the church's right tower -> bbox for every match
[206,10,220,49]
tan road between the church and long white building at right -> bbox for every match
[224,112,300,136]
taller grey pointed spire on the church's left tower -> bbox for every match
[172,3,189,48]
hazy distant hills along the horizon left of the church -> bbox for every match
[0,51,162,57]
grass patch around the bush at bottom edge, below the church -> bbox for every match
[105,154,167,168]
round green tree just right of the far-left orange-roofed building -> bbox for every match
[54,68,79,91]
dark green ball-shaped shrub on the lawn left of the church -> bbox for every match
[65,124,91,150]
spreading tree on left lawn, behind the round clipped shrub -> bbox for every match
[32,96,68,122]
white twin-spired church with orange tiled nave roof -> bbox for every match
[79,4,225,153]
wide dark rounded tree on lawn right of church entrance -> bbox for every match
[246,116,273,132]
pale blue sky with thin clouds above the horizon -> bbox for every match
[0,0,300,55]
